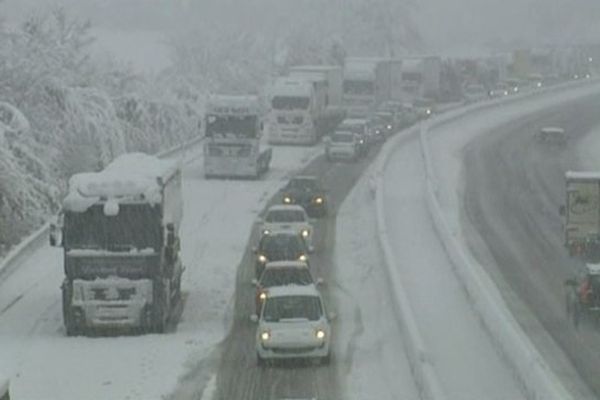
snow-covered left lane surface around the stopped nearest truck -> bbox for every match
[0,147,322,400]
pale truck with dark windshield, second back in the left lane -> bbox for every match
[204,95,272,179]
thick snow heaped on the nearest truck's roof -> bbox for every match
[63,153,178,212]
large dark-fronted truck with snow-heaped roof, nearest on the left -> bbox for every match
[50,153,184,336]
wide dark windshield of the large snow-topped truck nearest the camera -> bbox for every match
[63,204,162,251]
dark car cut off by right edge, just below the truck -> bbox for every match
[565,264,600,327]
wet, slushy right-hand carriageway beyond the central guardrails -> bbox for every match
[464,96,600,399]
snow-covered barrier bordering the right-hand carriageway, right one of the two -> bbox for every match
[420,81,600,400]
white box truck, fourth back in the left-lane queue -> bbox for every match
[342,58,402,118]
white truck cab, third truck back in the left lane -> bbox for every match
[268,77,327,145]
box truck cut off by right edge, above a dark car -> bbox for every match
[560,171,600,263]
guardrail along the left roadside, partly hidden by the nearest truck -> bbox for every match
[0,136,204,281]
